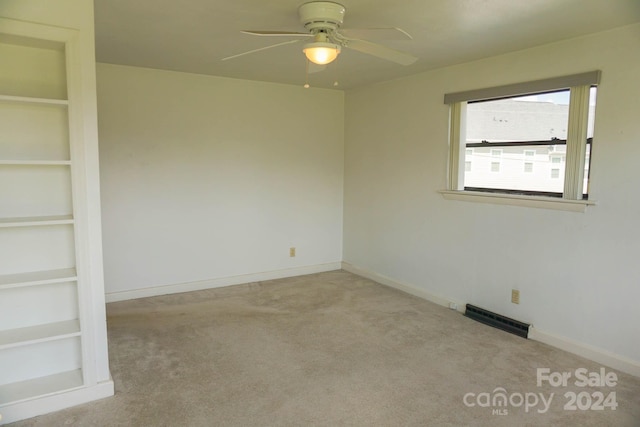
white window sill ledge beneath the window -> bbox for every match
[439,190,595,212]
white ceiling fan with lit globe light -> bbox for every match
[222,1,418,67]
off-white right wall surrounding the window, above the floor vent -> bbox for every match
[344,25,640,374]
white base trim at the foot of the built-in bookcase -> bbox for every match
[0,380,114,424]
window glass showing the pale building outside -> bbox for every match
[464,90,570,193]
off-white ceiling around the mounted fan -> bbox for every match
[94,0,640,89]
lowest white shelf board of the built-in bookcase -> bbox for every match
[0,369,83,409]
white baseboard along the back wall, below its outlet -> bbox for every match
[105,262,341,302]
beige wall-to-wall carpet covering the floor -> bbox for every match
[10,271,640,427]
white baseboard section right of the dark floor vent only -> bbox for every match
[529,326,640,377]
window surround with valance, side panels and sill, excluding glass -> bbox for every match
[440,71,600,212]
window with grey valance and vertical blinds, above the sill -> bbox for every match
[445,71,600,204]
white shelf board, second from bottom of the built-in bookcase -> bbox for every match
[0,320,80,351]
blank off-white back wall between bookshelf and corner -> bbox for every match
[98,64,344,300]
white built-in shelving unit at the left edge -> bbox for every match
[0,18,113,422]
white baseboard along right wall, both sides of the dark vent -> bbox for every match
[342,262,640,377]
